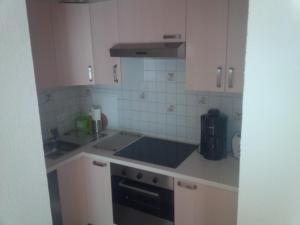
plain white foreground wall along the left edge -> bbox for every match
[0,0,52,225]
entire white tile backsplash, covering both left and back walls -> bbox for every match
[39,58,242,149]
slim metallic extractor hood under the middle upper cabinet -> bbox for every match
[110,42,185,58]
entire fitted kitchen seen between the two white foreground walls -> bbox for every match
[27,0,248,225]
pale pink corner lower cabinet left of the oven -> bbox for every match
[57,157,113,225]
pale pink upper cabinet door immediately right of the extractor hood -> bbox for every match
[186,0,228,91]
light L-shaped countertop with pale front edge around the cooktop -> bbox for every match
[46,131,239,192]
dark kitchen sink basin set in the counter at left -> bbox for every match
[44,140,80,159]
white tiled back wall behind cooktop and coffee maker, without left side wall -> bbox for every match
[90,58,242,149]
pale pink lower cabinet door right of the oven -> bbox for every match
[175,180,237,225]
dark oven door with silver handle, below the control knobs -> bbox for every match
[112,176,174,225]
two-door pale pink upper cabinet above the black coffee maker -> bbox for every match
[186,0,248,92]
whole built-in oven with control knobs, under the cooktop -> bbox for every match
[111,164,174,225]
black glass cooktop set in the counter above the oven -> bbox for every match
[115,137,198,168]
